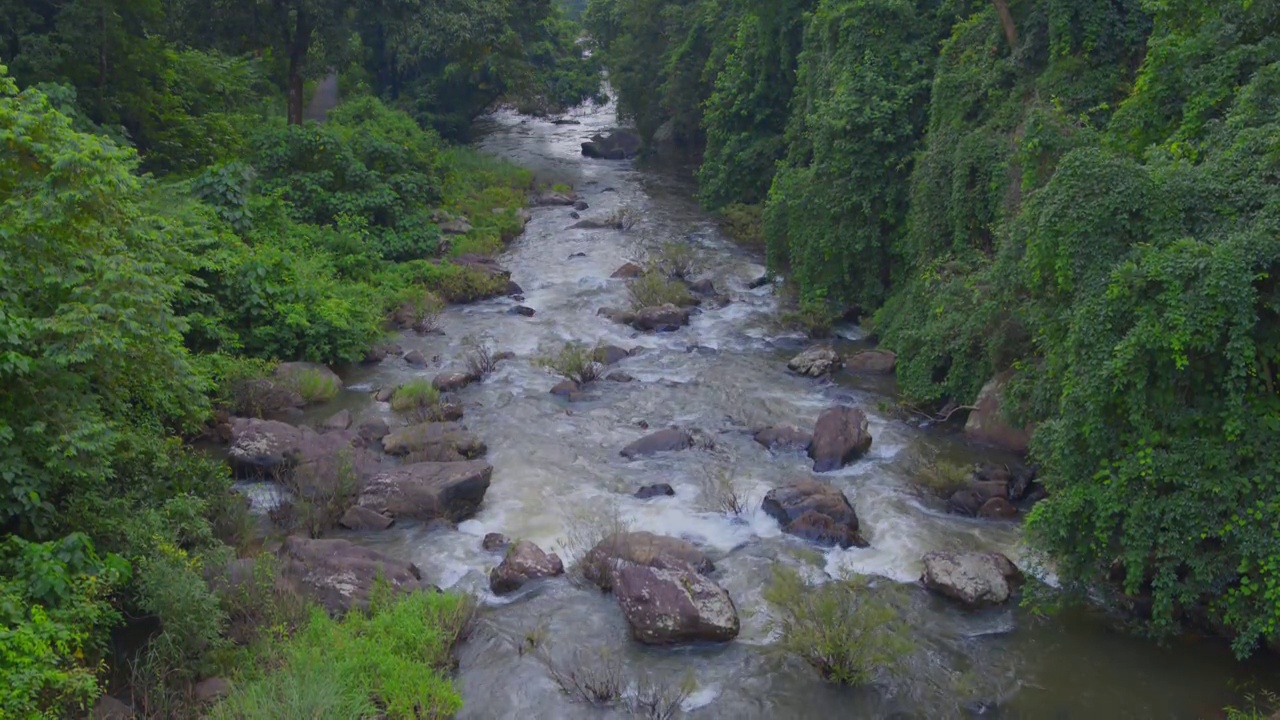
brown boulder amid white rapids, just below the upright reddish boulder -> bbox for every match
[762,479,868,548]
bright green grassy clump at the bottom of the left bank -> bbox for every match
[210,592,472,720]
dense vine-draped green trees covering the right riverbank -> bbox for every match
[585,0,1280,655]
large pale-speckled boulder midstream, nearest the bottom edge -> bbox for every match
[613,559,741,644]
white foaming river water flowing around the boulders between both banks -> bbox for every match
[267,98,1275,720]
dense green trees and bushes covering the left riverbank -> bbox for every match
[0,0,599,719]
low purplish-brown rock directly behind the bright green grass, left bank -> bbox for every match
[276,536,426,615]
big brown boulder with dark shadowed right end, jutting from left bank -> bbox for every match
[357,460,493,523]
